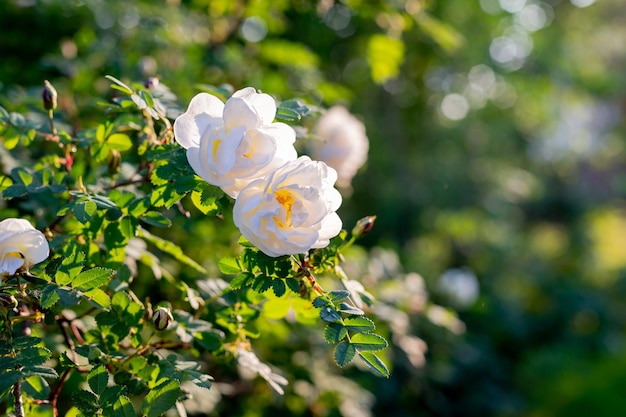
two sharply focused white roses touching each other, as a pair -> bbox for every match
[174,87,367,257]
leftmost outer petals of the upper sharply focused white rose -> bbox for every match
[174,93,224,149]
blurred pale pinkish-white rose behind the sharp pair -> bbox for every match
[310,106,369,187]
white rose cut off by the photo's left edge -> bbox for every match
[0,219,49,276]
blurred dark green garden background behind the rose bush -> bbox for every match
[0,0,626,417]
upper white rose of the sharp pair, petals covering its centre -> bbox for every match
[174,87,298,198]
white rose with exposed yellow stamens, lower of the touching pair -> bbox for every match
[233,156,341,257]
